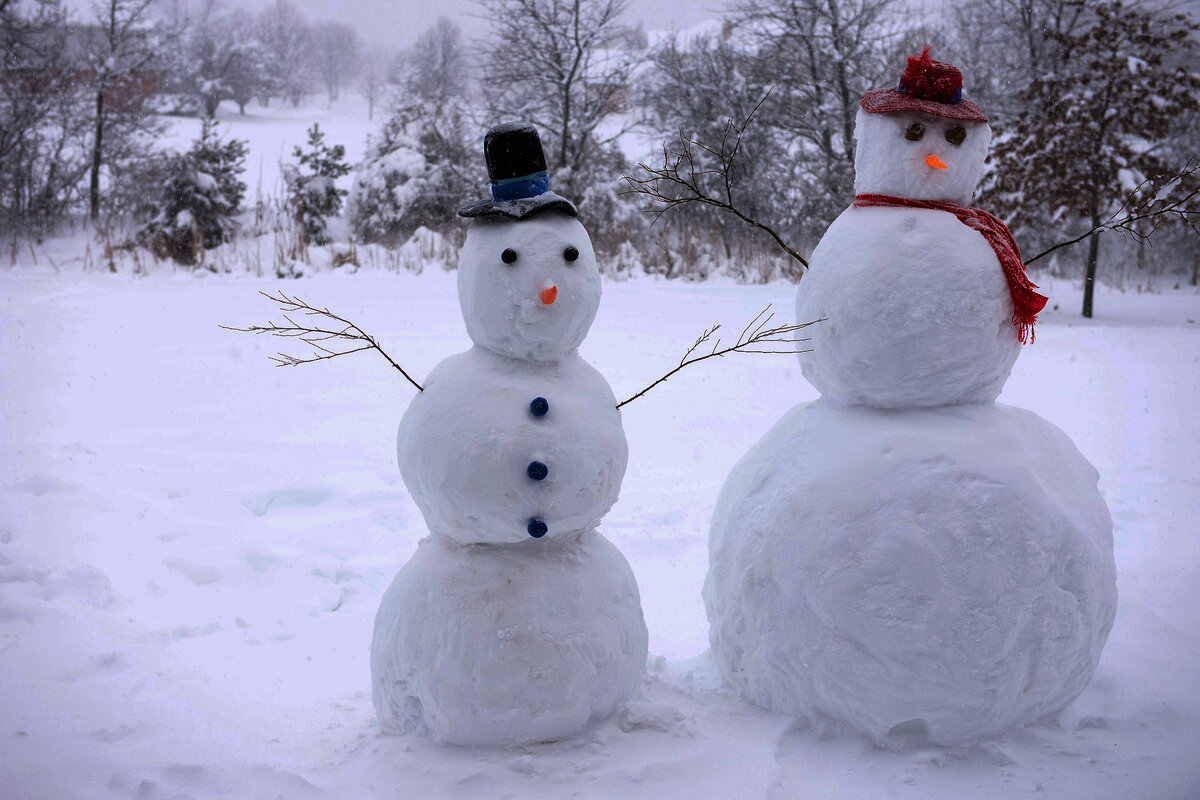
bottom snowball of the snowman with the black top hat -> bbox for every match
[371,531,647,746]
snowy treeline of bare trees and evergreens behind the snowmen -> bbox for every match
[0,0,1200,288]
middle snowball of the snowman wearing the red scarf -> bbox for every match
[796,207,1020,408]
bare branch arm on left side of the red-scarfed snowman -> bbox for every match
[622,89,809,269]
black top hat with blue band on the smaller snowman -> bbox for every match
[458,122,580,219]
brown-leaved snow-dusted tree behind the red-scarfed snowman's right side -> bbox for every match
[988,0,1200,317]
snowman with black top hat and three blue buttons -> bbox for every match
[371,124,647,745]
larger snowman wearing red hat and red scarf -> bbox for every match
[704,49,1116,745]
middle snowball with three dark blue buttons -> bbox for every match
[396,347,629,545]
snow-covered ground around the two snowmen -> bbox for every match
[0,261,1200,800]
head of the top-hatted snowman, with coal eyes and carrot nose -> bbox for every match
[458,211,600,361]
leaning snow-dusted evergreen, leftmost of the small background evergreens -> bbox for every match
[138,119,246,266]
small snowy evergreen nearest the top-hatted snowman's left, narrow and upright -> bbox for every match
[283,122,350,245]
